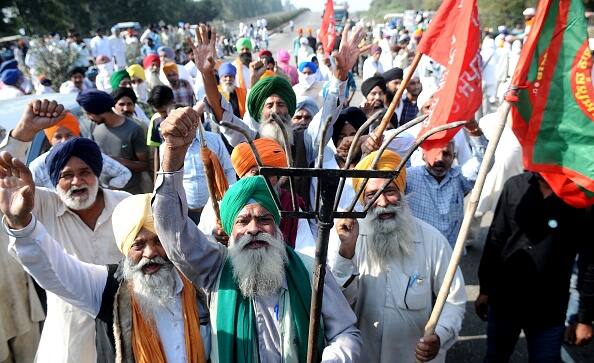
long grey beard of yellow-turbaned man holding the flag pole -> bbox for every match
[363,202,414,269]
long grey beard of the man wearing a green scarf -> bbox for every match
[229,227,288,298]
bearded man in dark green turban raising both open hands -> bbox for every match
[191,26,365,206]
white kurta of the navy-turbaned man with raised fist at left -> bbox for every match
[0,136,129,363]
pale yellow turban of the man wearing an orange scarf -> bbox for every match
[111,194,157,256]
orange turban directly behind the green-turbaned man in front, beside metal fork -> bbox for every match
[231,138,287,178]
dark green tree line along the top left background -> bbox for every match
[0,0,283,36]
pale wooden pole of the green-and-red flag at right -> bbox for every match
[418,101,511,362]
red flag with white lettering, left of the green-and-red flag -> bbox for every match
[417,0,483,150]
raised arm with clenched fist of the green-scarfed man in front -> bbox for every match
[152,107,227,290]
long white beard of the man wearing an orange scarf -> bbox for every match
[123,256,175,320]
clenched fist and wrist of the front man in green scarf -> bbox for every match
[161,107,200,171]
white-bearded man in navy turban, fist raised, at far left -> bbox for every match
[0,100,129,363]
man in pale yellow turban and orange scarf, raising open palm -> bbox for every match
[0,186,210,363]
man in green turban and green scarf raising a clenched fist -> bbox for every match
[153,108,361,363]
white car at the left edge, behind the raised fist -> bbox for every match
[0,93,92,165]
